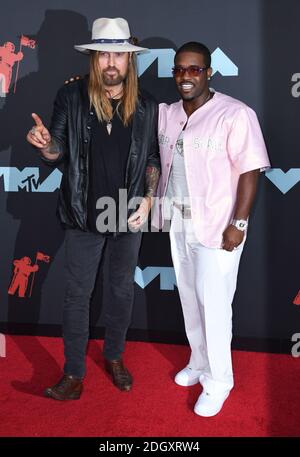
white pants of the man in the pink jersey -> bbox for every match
[170,208,244,393]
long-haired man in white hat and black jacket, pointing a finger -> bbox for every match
[27,18,160,400]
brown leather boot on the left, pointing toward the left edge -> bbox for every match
[44,375,83,401]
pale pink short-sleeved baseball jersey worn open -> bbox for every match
[152,92,270,248]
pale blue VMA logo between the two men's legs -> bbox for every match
[134,267,177,290]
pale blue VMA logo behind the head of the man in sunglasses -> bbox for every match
[137,48,238,78]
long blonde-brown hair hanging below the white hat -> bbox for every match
[88,51,138,126]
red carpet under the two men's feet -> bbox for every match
[0,336,300,437]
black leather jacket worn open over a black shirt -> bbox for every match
[41,77,160,230]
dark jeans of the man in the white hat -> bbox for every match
[63,229,142,378]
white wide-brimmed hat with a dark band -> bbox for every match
[74,17,147,54]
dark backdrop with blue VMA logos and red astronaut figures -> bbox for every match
[0,0,300,352]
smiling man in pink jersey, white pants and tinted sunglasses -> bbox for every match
[152,42,270,417]
